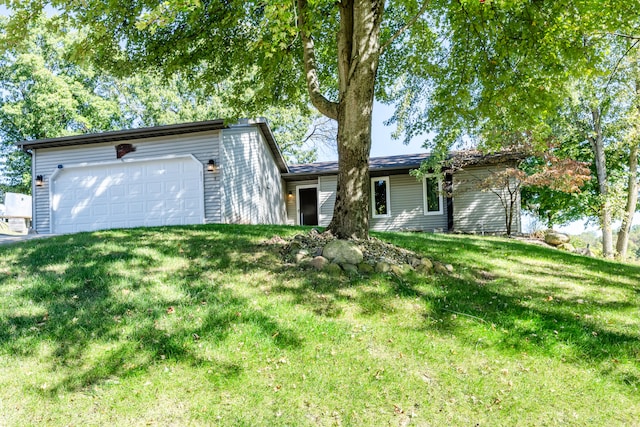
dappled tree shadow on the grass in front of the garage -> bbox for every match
[0,226,302,395]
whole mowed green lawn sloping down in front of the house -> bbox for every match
[0,225,640,426]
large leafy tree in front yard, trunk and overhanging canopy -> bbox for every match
[2,0,640,237]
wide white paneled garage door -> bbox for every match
[51,156,204,233]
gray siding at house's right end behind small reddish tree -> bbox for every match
[453,166,521,233]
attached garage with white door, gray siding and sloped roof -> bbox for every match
[18,119,287,234]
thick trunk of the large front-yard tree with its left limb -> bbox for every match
[298,0,384,239]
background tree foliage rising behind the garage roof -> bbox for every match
[0,18,330,197]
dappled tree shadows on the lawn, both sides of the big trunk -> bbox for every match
[0,226,640,394]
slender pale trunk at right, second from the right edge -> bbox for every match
[589,108,613,258]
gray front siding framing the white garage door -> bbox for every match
[32,131,221,233]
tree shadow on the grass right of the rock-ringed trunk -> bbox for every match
[273,233,640,389]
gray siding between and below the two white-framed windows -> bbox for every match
[370,174,447,231]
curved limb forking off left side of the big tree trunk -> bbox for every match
[298,0,338,120]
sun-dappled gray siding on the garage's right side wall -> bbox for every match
[221,127,287,224]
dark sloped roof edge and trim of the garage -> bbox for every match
[16,118,288,172]
